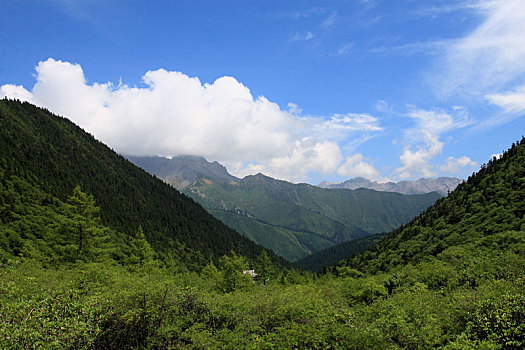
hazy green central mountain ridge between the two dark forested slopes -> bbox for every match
[184,174,440,260]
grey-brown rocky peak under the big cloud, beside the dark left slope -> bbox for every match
[125,156,239,191]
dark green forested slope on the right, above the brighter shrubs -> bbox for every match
[347,138,525,273]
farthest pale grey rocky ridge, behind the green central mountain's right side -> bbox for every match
[319,177,463,196]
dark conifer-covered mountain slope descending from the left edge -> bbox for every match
[0,99,286,269]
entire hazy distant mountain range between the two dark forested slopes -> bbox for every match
[127,156,440,261]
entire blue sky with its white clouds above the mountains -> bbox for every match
[0,0,525,184]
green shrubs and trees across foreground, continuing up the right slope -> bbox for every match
[0,102,525,350]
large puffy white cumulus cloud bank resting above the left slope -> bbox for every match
[0,58,380,181]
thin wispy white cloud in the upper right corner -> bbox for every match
[431,0,525,97]
